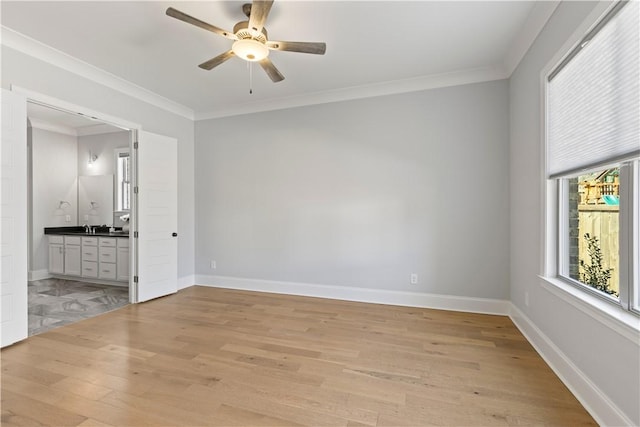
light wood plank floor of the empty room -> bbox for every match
[1,287,595,426]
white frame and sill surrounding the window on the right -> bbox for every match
[540,2,640,320]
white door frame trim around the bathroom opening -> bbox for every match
[10,84,142,304]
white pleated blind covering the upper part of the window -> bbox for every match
[547,1,640,178]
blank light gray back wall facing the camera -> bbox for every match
[196,81,509,299]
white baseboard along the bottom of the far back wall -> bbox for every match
[195,275,510,316]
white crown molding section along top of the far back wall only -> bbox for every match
[195,67,509,120]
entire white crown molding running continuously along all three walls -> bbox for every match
[1,0,560,120]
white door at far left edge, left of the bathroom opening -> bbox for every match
[0,89,28,347]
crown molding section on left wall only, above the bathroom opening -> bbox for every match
[1,25,195,120]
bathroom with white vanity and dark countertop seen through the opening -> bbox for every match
[27,103,131,335]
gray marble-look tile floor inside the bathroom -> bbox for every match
[28,279,129,336]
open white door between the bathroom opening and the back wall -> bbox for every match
[136,132,178,302]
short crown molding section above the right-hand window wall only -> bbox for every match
[503,0,560,76]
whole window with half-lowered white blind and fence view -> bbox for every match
[545,1,640,313]
